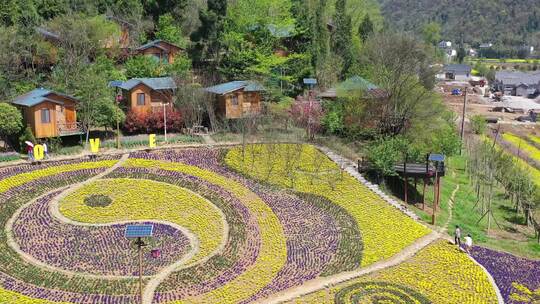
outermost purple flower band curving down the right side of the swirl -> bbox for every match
[126,149,354,302]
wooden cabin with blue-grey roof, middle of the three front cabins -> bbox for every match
[109,77,176,114]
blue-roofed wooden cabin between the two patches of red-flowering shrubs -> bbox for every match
[205,81,264,119]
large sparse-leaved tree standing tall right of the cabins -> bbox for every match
[364,33,440,135]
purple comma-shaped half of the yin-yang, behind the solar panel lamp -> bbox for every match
[13,191,190,276]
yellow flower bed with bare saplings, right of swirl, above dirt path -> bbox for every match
[225,144,430,266]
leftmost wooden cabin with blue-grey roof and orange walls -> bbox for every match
[11,88,82,138]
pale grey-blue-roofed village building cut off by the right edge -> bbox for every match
[493,71,540,97]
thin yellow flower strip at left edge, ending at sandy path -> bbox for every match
[0,160,117,193]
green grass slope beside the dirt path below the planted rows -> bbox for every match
[412,156,540,259]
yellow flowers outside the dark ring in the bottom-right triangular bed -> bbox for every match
[290,240,497,304]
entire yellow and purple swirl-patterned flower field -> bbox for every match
[0,144,538,304]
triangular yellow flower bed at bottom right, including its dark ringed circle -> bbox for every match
[299,241,497,304]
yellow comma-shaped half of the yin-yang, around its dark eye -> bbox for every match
[60,178,225,262]
